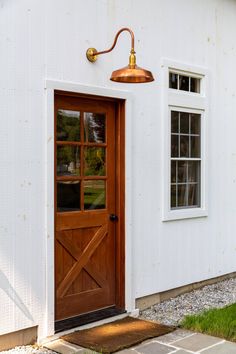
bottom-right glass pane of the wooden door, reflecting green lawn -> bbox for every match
[84,180,106,210]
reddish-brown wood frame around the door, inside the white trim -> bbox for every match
[54,90,125,316]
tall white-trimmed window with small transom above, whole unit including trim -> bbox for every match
[163,60,207,220]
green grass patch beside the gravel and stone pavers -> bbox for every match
[180,304,236,342]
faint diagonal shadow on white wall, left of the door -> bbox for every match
[0,270,34,322]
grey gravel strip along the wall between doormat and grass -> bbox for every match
[140,278,236,326]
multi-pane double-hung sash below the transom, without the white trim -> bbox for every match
[170,108,201,209]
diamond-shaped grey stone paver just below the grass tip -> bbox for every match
[171,333,222,354]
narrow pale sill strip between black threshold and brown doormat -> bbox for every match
[42,311,129,345]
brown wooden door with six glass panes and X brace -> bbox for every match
[55,94,124,329]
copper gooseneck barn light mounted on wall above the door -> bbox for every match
[86,27,154,84]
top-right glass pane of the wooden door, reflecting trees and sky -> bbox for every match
[84,112,106,143]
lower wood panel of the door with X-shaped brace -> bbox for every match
[55,220,115,320]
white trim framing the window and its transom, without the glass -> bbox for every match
[162,59,209,221]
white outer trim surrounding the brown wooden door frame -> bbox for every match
[43,79,135,340]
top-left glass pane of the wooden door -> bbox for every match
[56,109,80,141]
